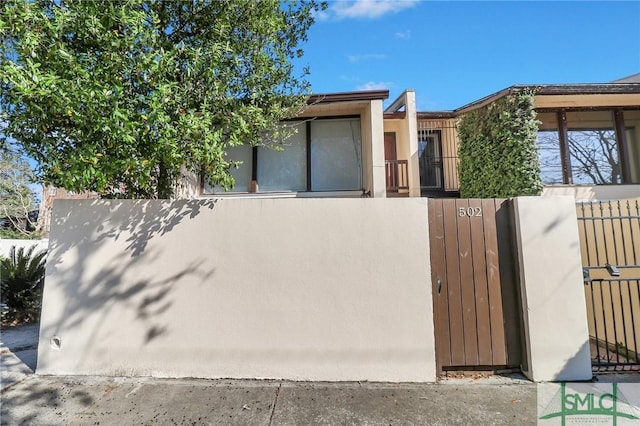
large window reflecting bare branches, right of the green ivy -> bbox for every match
[537,110,639,185]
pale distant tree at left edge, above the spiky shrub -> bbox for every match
[0,144,36,238]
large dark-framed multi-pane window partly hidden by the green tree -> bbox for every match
[204,117,362,193]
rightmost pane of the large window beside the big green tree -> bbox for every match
[311,118,362,191]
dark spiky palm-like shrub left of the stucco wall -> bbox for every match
[0,246,47,323]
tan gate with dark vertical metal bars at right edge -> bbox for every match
[577,199,640,371]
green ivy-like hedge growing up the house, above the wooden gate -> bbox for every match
[458,91,542,198]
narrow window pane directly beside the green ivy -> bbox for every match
[537,112,563,185]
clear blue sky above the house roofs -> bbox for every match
[299,0,640,111]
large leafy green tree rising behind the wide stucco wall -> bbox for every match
[0,0,324,198]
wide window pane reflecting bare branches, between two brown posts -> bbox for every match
[567,111,622,185]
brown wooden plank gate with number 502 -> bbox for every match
[429,199,522,372]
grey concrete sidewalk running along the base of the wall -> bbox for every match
[0,375,536,425]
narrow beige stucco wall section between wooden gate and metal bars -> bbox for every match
[514,197,592,382]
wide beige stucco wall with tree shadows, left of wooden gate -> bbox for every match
[37,199,435,382]
